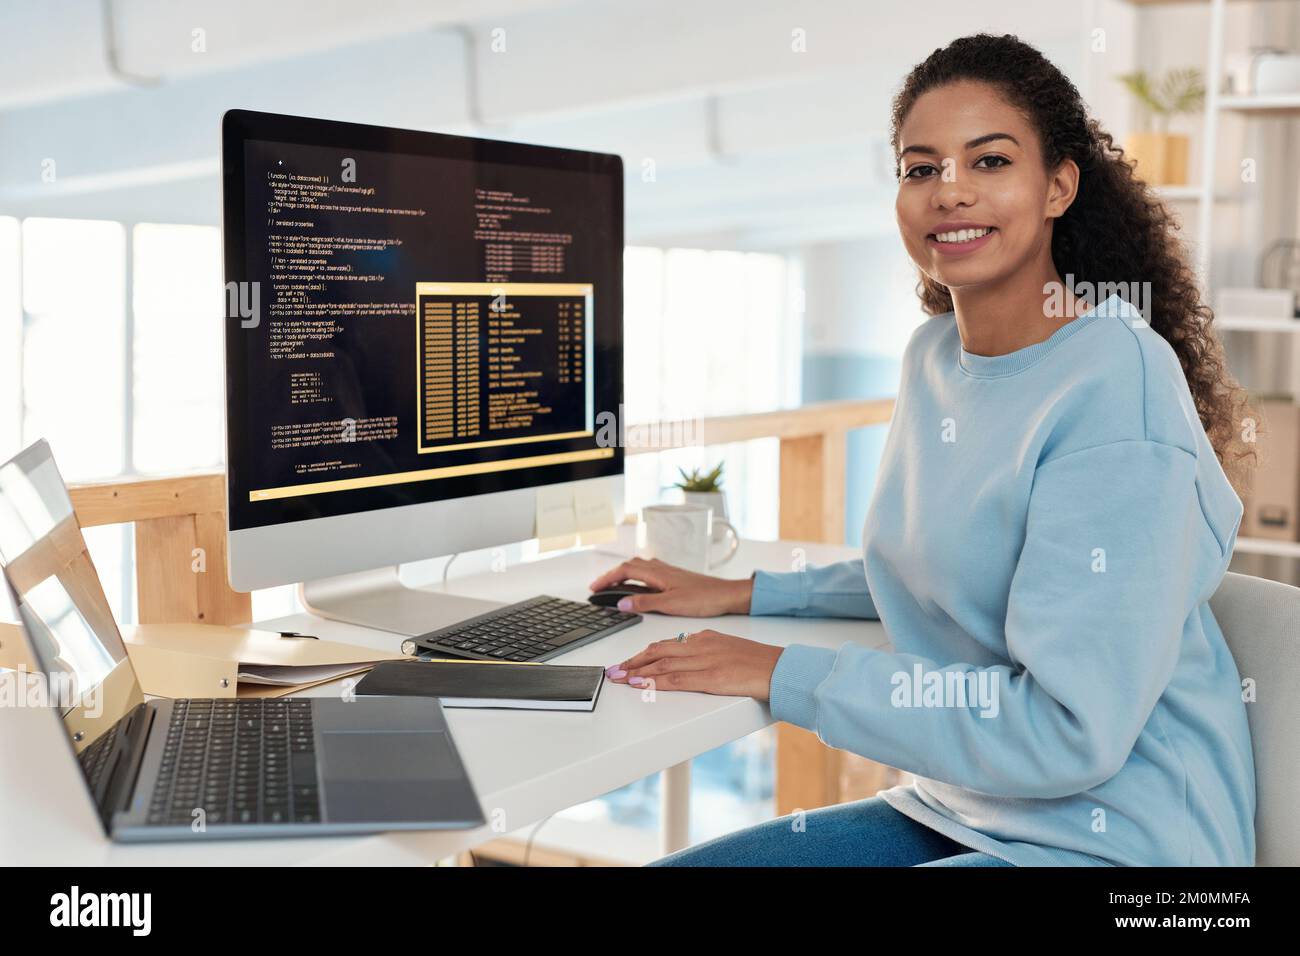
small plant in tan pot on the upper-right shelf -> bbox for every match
[1118,66,1205,186]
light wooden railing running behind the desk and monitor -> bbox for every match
[72,398,893,827]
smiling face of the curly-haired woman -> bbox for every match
[894,81,1078,290]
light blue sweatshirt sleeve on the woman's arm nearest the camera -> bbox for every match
[771,440,1231,797]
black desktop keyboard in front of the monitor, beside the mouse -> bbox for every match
[402,594,641,662]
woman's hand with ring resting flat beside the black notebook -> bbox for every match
[605,631,784,701]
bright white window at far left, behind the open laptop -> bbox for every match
[0,217,224,622]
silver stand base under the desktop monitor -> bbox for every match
[298,567,503,637]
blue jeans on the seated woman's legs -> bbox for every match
[650,797,1013,866]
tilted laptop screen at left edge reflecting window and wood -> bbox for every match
[0,441,144,752]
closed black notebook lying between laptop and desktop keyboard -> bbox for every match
[356,659,605,711]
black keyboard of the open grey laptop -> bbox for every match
[148,697,321,826]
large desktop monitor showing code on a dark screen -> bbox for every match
[222,111,623,633]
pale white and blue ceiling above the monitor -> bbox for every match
[0,0,1135,248]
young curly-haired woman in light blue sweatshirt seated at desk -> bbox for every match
[592,34,1255,866]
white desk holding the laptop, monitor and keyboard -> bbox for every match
[0,541,885,866]
